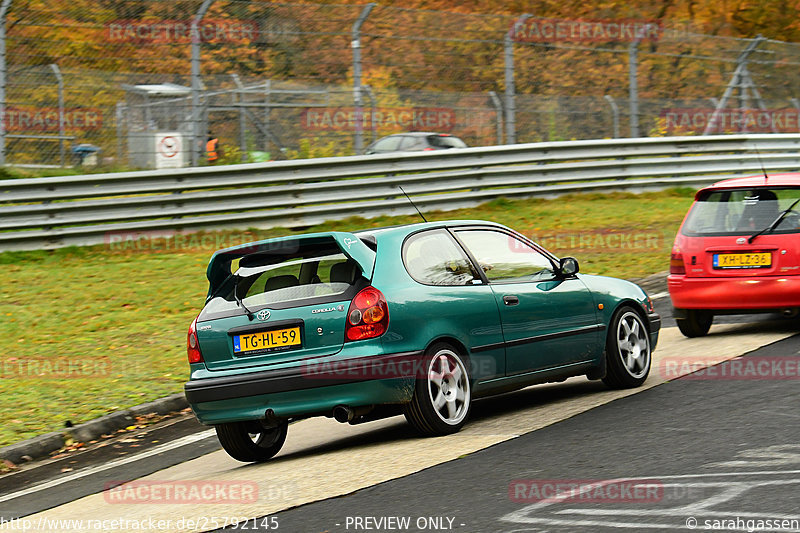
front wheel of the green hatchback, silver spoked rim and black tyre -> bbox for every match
[603,305,653,389]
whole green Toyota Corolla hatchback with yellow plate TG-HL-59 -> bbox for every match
[185,221,661,462]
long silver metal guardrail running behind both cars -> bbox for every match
[0,134,800,250]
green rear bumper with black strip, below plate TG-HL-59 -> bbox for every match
[184,351,423,424]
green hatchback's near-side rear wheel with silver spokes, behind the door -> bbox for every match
[403,342,472,436]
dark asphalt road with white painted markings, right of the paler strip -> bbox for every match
[260,330,800,533]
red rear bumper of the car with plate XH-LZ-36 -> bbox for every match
[667,274,800,311]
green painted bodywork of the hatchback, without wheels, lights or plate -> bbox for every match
[185,221,660,425]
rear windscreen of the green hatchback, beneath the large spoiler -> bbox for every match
[201,245,361,318]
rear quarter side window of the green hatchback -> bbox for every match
[403,230,480,285]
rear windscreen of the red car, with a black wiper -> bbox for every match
[681,187,800,237]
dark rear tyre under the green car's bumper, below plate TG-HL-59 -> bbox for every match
[214,421,289,463]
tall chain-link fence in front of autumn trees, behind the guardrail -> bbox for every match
[0,0,800,168]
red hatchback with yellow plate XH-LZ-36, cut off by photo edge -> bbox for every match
[668,173,800,337]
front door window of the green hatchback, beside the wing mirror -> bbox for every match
[456,230,556,283]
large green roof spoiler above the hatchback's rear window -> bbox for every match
[206,231,375,299]
